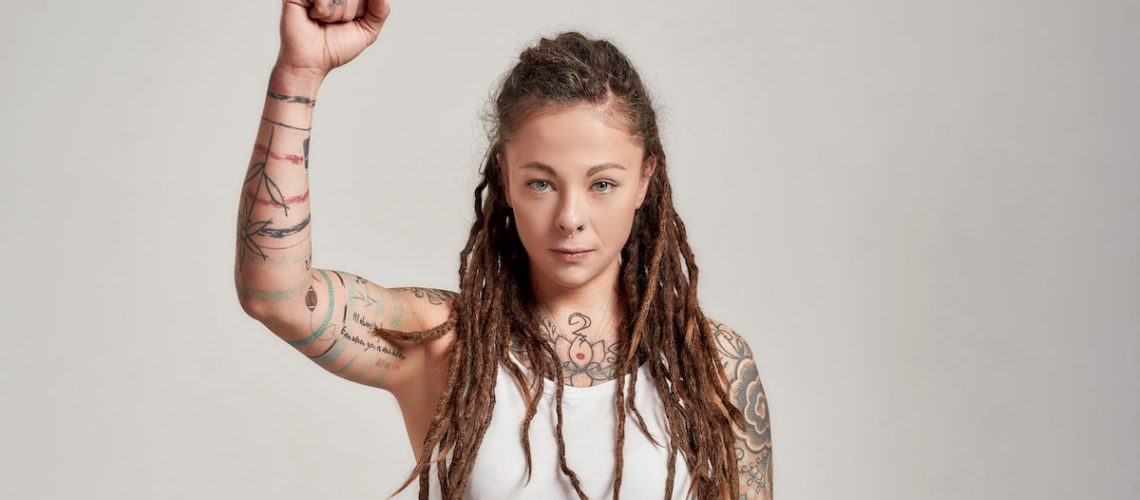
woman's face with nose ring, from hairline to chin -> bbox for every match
[498,104,656,296]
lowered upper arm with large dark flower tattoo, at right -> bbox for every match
[709,319,773,500]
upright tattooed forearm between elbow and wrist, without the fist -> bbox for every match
[234,69,320,313]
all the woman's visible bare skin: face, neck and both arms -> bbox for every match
[235,0,773,499]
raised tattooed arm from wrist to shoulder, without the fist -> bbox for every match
[234,67,454,392]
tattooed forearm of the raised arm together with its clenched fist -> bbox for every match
[234,0,390,317]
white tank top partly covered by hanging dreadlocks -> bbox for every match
[431,353,691,500]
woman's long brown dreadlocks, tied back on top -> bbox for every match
[373,32,743,499]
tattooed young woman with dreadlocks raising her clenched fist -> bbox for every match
[235,0,773,499]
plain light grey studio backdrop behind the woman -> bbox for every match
[0,0,1140,500]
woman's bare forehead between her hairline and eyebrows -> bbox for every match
[504,104,643,170]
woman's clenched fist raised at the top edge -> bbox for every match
[277,0,391,80]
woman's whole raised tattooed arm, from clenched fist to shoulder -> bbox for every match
[234,0,454,392]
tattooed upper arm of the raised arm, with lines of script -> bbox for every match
[251,268,455,391]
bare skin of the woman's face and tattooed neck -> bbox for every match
[497,104,656,387]
